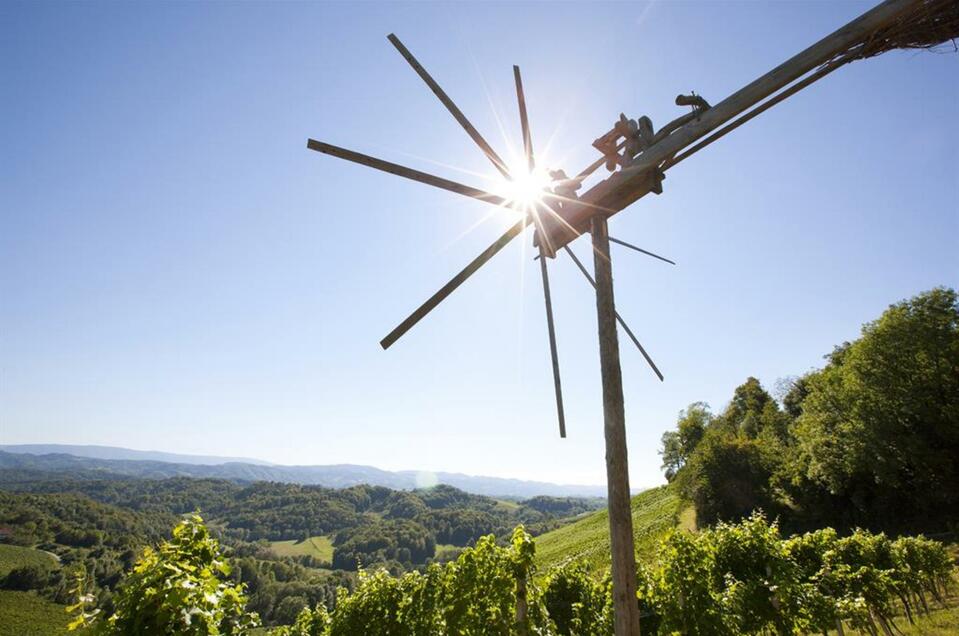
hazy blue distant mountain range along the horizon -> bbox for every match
[0,444,606,498]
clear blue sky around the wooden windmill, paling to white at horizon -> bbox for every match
[0,2,959,487]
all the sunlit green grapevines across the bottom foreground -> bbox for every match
[63,513,953,636]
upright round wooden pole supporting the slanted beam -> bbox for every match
[590,214,639,636]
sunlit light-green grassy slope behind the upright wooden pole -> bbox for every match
[536,486,681,573]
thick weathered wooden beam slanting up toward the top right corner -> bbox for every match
[549,0,919,250]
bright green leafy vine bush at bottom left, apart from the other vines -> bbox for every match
[71,515,258,636]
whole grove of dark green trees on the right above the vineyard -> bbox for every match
[661,288,959,532]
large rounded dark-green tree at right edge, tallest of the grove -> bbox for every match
[794,288,959,527]
